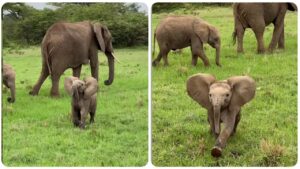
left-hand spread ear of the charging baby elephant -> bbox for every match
[186,73,216,109]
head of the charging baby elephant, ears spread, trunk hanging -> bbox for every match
[187,73,256,134]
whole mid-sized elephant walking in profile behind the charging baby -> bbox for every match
[152,16,221,66]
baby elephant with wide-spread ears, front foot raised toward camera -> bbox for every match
[187,73,256,157]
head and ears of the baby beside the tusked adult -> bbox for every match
[65,76,98,100]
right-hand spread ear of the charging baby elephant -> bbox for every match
[227,76,256,111]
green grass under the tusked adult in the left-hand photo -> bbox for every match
[2,47,148,166]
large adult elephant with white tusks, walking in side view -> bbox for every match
[29,21,114,96]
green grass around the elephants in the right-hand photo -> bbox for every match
[152,7,298,166]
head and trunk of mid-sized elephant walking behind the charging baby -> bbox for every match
[193,20,221,66]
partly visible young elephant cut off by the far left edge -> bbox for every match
[2,64,16,103]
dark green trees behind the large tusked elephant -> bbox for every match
[2,3,148,47]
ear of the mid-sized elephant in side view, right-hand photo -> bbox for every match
[193,19,210,43]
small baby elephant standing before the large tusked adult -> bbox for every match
[65,76,98,129]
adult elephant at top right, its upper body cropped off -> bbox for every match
[233,3,297,53]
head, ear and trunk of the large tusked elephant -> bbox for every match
[93,23,115,85]
